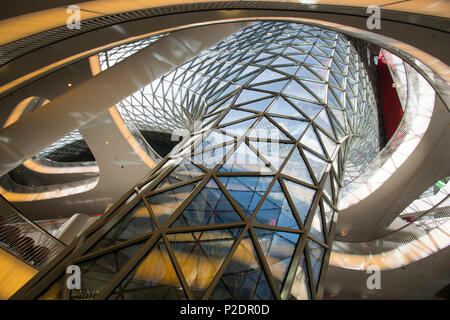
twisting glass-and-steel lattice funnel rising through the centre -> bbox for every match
[22,22,378,299]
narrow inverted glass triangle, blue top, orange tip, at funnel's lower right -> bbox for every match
[255,228,299,291]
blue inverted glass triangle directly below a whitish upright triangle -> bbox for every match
[219,176,273,218]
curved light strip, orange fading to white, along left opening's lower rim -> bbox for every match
[0,177,99,202]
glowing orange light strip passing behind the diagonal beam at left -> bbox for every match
[89,55,157,169]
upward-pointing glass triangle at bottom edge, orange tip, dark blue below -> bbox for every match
[211,234,274,300]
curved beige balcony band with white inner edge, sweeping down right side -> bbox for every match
[336,89,450,241]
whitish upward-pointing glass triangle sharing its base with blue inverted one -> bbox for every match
[219,142,272,172]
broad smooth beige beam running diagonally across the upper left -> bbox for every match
[0,24,250,175]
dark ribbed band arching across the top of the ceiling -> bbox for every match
[0,1,450,67]
